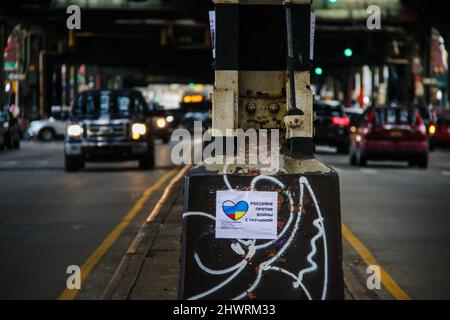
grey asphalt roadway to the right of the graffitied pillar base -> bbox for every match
[318,146,450,299]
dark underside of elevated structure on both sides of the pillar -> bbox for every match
[0,0,442,82]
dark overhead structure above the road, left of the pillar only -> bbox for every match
[0,0,213,82]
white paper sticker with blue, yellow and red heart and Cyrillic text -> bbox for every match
[216,191,278,239]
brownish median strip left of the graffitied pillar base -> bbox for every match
[102,174,183,300]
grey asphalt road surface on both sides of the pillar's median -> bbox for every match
[0,142,450,299]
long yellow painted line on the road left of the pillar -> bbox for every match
[58,169,179,300]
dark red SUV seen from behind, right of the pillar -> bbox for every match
[350,107,429,168]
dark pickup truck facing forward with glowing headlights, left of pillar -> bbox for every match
[64,90,155,171]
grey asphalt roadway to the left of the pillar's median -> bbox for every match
[0,142,176,299]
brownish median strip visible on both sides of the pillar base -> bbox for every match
[102,179,391,300]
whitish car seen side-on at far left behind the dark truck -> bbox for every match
[26,107,69,142]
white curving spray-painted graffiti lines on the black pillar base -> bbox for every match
[183,171,328,300]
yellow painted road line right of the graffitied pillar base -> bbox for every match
[342,224,411,300]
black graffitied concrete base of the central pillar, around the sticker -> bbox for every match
[179,155,344,300]
